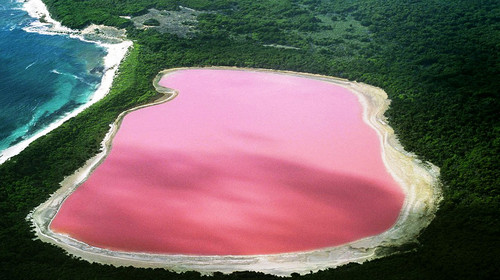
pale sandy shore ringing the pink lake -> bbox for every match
[27,67,442,276]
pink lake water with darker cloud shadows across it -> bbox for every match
[51,69,404,255]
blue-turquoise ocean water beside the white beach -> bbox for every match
[0,0,106,158]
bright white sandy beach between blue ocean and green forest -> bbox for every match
[0,0,132,164]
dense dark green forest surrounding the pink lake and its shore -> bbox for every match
[0,0,500,279]
